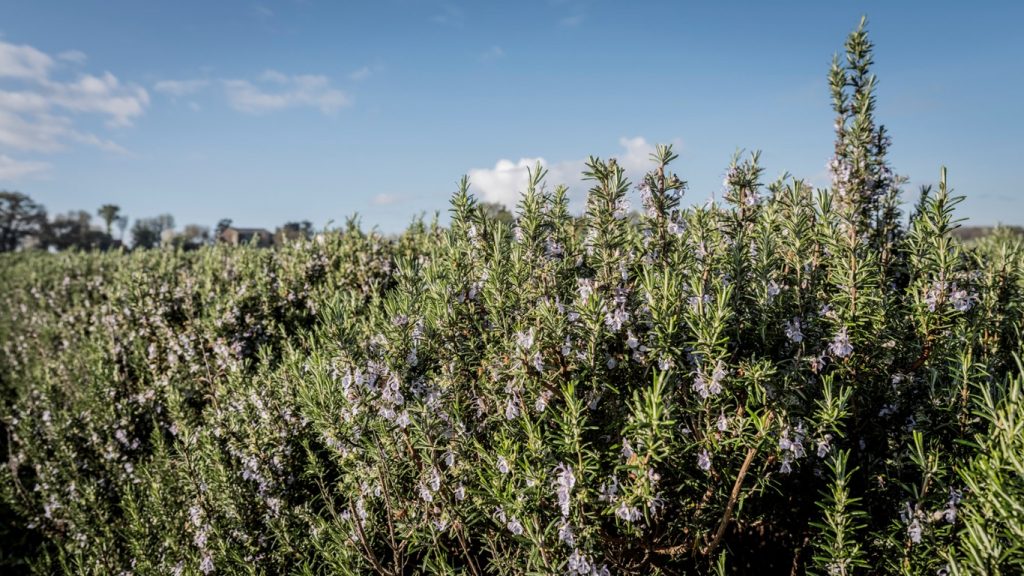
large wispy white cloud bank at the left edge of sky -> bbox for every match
[0,41,150,179]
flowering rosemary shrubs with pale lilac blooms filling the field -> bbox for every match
[0,17,1024,575]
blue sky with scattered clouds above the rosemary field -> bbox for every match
[0,0,1024,232]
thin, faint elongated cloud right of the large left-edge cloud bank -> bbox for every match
[222,70,352,114]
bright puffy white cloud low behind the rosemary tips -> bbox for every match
[468,136,682,208]
